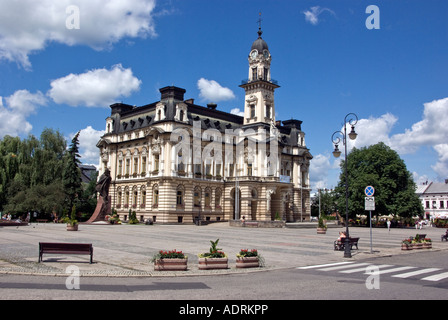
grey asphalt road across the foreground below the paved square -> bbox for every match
[0,252,448,301]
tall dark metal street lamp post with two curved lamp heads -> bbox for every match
[331,113,358,258]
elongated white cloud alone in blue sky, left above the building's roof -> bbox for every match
[48,64,141,107]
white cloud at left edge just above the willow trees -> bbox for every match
[0,90,47,138]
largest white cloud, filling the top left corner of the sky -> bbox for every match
[0,0,156,69]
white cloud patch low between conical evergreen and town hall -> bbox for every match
[74,126,106,167]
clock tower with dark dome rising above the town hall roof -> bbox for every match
[240,26,279,125]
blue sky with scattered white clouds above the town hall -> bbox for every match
[0,0,448,192]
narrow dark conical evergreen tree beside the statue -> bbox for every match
[62,131,82,208]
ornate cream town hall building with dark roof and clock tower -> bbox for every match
[97,26,312,223]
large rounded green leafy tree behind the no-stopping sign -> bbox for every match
[336,142,423,218]
